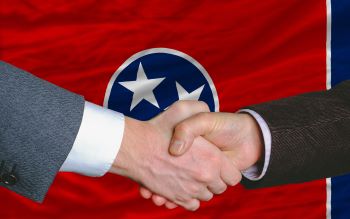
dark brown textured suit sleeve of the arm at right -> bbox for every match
[242,81,350,188]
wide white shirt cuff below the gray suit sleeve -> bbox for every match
[60,102,124,177]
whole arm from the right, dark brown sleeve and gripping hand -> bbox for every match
[170,81,350,188]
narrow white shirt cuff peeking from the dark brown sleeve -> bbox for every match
[238,109,271,181]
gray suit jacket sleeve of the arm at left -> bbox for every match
[0,61,84,202]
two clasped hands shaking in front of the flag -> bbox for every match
[110,101,263,211]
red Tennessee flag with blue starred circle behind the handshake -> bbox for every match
[0,0,350,219]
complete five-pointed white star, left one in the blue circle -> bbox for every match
[119,62,165,111]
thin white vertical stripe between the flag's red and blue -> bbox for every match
[326,0,332,219]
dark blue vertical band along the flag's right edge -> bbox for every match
[331,0,350,219]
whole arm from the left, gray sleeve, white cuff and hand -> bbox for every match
[0,62,240,210]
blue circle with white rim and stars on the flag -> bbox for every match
[104,48,219,120]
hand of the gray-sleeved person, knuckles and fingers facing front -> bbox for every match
[110,101,241,210]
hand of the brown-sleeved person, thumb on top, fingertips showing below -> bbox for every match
[140,112,263,208]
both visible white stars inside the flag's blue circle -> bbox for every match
[119,63,205,111]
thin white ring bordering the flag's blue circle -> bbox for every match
[103,48,219,112]
